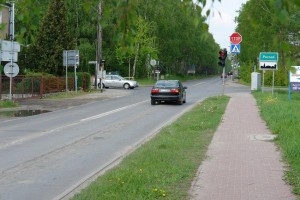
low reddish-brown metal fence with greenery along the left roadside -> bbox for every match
[0,76,90,99]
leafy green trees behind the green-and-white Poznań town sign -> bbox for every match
[237,0,300,85]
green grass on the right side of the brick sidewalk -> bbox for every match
[254,91,300,195]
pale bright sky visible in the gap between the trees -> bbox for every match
[204,0,248,51]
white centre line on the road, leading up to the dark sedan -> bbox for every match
[0,100,148,149]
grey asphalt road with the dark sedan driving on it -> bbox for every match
[0,77,250,200]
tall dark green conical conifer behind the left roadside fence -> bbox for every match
[27,0,75,76]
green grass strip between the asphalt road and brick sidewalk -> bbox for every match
[72,96,229,200]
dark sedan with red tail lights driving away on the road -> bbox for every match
[151,80,187,105]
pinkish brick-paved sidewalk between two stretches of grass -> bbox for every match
[190,92,296,200]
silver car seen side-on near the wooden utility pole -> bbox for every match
[98,75,139,89]
